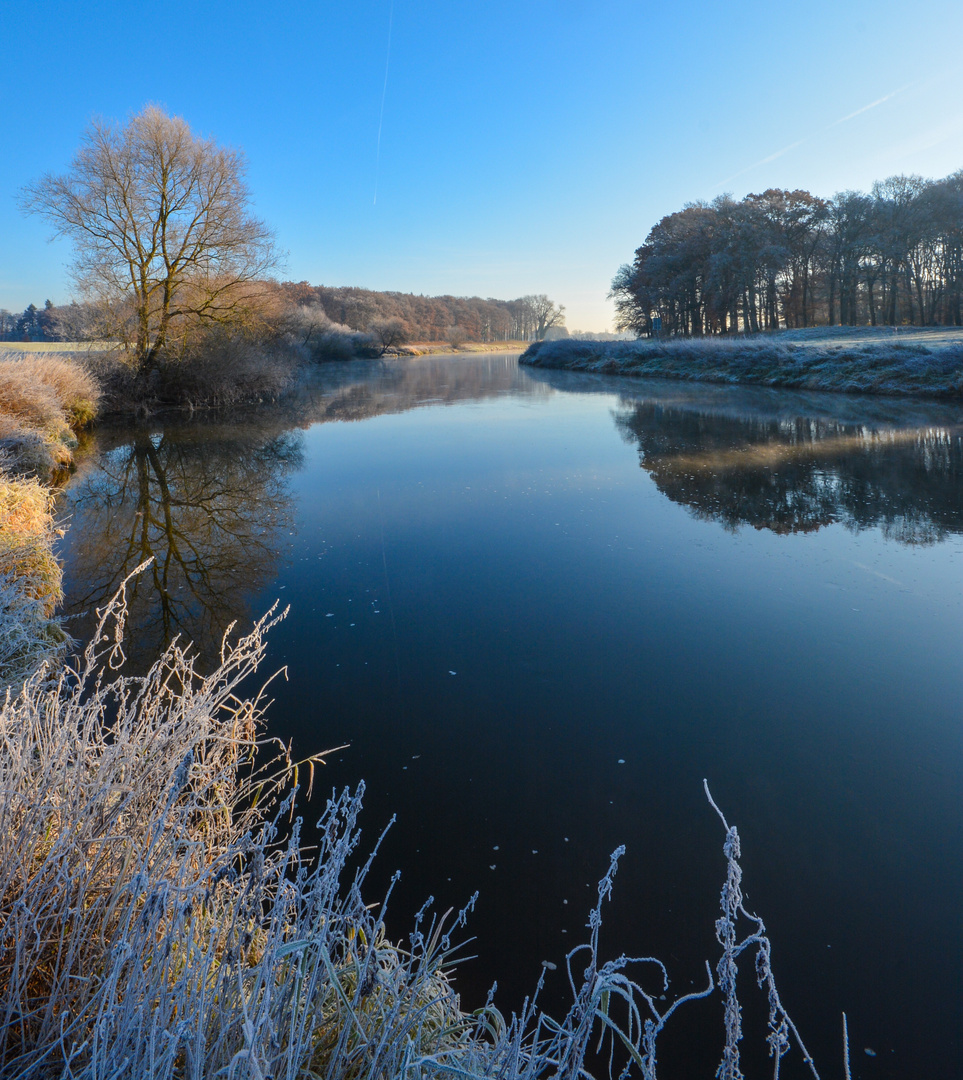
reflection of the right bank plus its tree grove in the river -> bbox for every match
[528,368,963,544]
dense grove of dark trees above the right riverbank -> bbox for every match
[610,171,963,336]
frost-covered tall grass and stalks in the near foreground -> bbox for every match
[0,578,829,1080]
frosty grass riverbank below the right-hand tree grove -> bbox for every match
[519,327,963,399]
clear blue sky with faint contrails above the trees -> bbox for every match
[0,0,963,329]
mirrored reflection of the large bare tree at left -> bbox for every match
[62,417,301,669]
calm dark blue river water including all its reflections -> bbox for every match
[56,357,963,1078]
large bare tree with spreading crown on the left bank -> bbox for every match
[22,105,277,376]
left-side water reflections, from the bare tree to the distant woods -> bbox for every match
[60,355,537,666]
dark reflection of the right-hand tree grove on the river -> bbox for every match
[615,400,963,544]
